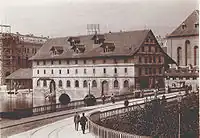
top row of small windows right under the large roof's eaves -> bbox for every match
[37,59,128,65]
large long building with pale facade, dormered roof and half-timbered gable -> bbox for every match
[31,30,174,100]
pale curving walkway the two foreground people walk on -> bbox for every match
[9,93,180,138]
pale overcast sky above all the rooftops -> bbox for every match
[0,0,198,37]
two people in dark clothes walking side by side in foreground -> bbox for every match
[74,112,87,134]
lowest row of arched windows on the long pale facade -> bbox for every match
[37,80,129,88]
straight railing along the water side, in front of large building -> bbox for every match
[1,89,184,118]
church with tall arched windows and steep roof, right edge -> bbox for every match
[167,10,199,67]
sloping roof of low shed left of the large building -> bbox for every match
[6,68,33,80]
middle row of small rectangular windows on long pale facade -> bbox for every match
[37,68,128,74]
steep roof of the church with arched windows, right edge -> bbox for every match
[167,10,199,38]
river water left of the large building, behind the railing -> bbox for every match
[0,95,50,112]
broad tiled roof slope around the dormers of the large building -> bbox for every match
[30,30,151,60]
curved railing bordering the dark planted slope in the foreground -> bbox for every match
[88,89,188,138]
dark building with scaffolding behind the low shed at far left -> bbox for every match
[0,25,48,85]
